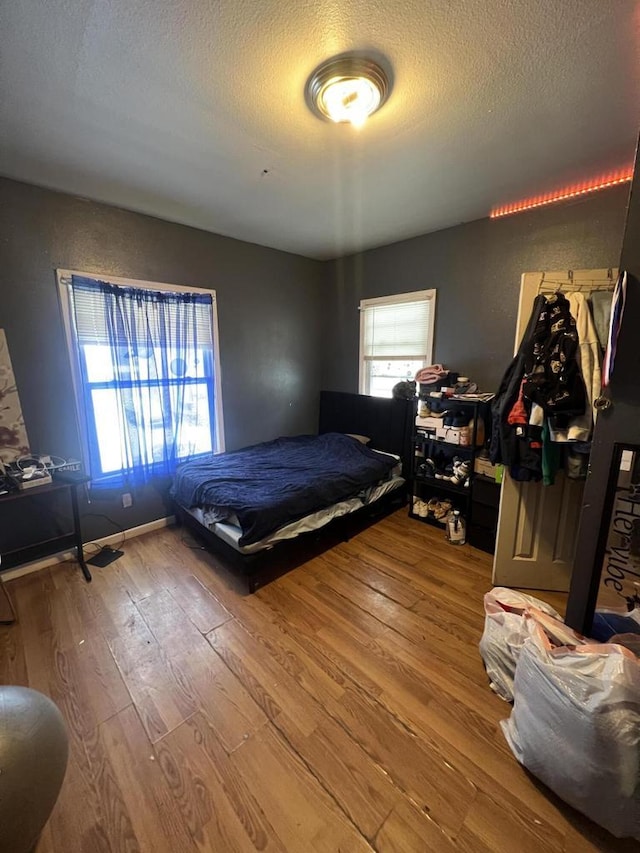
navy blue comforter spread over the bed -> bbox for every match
[172,432,396,545]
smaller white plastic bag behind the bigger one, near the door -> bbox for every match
[480,586,560,702]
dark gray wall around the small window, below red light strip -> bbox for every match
[323,184,629,391]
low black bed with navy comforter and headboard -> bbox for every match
[172,392,413,592]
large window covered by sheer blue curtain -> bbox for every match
[58,270,224,486]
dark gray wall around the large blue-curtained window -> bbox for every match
[0,179,325,536]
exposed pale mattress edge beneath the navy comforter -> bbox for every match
[185,470,405,554]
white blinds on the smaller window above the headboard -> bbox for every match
[360,291,435,361]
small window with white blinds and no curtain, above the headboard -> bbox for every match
[360,290,436,397]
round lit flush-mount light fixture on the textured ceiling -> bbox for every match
[305,53,391,127]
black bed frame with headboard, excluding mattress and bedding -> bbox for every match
[174,391,415,592]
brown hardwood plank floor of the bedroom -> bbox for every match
[0,510,638,853]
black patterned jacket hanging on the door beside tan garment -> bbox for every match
[490,293,586,482]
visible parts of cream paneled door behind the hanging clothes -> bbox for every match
[493,270,617,592]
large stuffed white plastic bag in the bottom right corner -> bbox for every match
[502,626,640,840]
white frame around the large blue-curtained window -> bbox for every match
[56,269,225,482]
